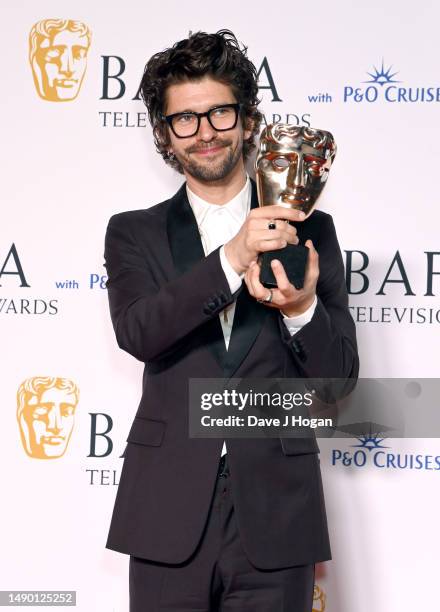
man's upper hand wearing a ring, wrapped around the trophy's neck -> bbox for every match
[225,206,305,274]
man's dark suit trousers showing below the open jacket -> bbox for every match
[129,455,315,612]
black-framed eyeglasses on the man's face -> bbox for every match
[164,102,241,138]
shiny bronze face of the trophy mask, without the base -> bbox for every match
[256,128,331,214]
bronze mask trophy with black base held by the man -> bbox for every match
[255,123,336,289]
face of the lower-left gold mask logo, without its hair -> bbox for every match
[24,388,76,459]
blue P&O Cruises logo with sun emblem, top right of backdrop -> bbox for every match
[343,60,440,104]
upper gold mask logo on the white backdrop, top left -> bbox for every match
[29,19,92,102]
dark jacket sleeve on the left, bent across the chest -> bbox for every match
[104,213,234,362]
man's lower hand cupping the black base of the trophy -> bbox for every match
[244,238,319,317]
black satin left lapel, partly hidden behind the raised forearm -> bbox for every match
[167,183,226,368]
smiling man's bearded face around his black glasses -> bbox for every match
[164,77,250,182]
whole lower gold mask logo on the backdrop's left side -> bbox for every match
[17,376,79,459]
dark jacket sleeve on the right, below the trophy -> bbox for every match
[280,215,359,379]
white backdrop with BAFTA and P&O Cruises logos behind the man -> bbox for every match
[0,0,440,612]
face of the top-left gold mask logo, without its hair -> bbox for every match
[36,30,89,101]
